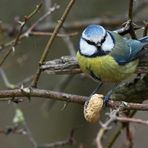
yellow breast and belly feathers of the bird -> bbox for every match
[77,52,139,82]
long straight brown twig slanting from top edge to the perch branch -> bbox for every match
[32,0,75,87]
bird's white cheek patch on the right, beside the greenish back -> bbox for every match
[102,34,114,51]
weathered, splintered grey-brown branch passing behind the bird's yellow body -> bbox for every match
[41,50,148,74]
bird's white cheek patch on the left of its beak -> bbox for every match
[80,39,97,56]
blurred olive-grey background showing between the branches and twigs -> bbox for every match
[0,0,148,148]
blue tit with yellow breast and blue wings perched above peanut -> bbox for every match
[76,24,148,102]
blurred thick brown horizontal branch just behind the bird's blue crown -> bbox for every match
[36,16,147,31]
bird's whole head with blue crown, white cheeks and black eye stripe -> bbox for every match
[79,25,114,57]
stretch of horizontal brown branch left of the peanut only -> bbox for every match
[0,88,87,104]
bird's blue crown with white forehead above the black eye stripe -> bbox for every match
[82,24,106,44]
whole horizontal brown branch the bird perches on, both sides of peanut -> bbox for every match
[0,87,148,111]
